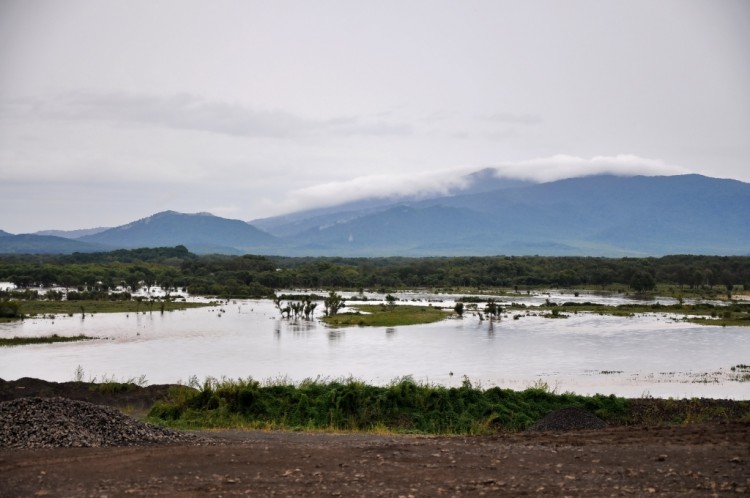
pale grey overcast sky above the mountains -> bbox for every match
[0,0,750,233]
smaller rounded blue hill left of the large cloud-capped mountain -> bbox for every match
[78,211,283,254]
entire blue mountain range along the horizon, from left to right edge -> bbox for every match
[0,171,750,257]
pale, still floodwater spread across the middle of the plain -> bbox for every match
[0,293,750,399]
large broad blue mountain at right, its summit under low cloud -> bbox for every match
[274,175,750,256]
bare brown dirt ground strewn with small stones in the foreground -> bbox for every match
[0,424,750,497]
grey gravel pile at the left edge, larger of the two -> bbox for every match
[0,398,200,448]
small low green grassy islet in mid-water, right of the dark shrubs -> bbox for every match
[323,305,450,327]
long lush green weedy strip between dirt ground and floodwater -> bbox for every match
[148,377,628,434]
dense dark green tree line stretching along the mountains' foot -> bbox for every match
[0,246,750,297]
